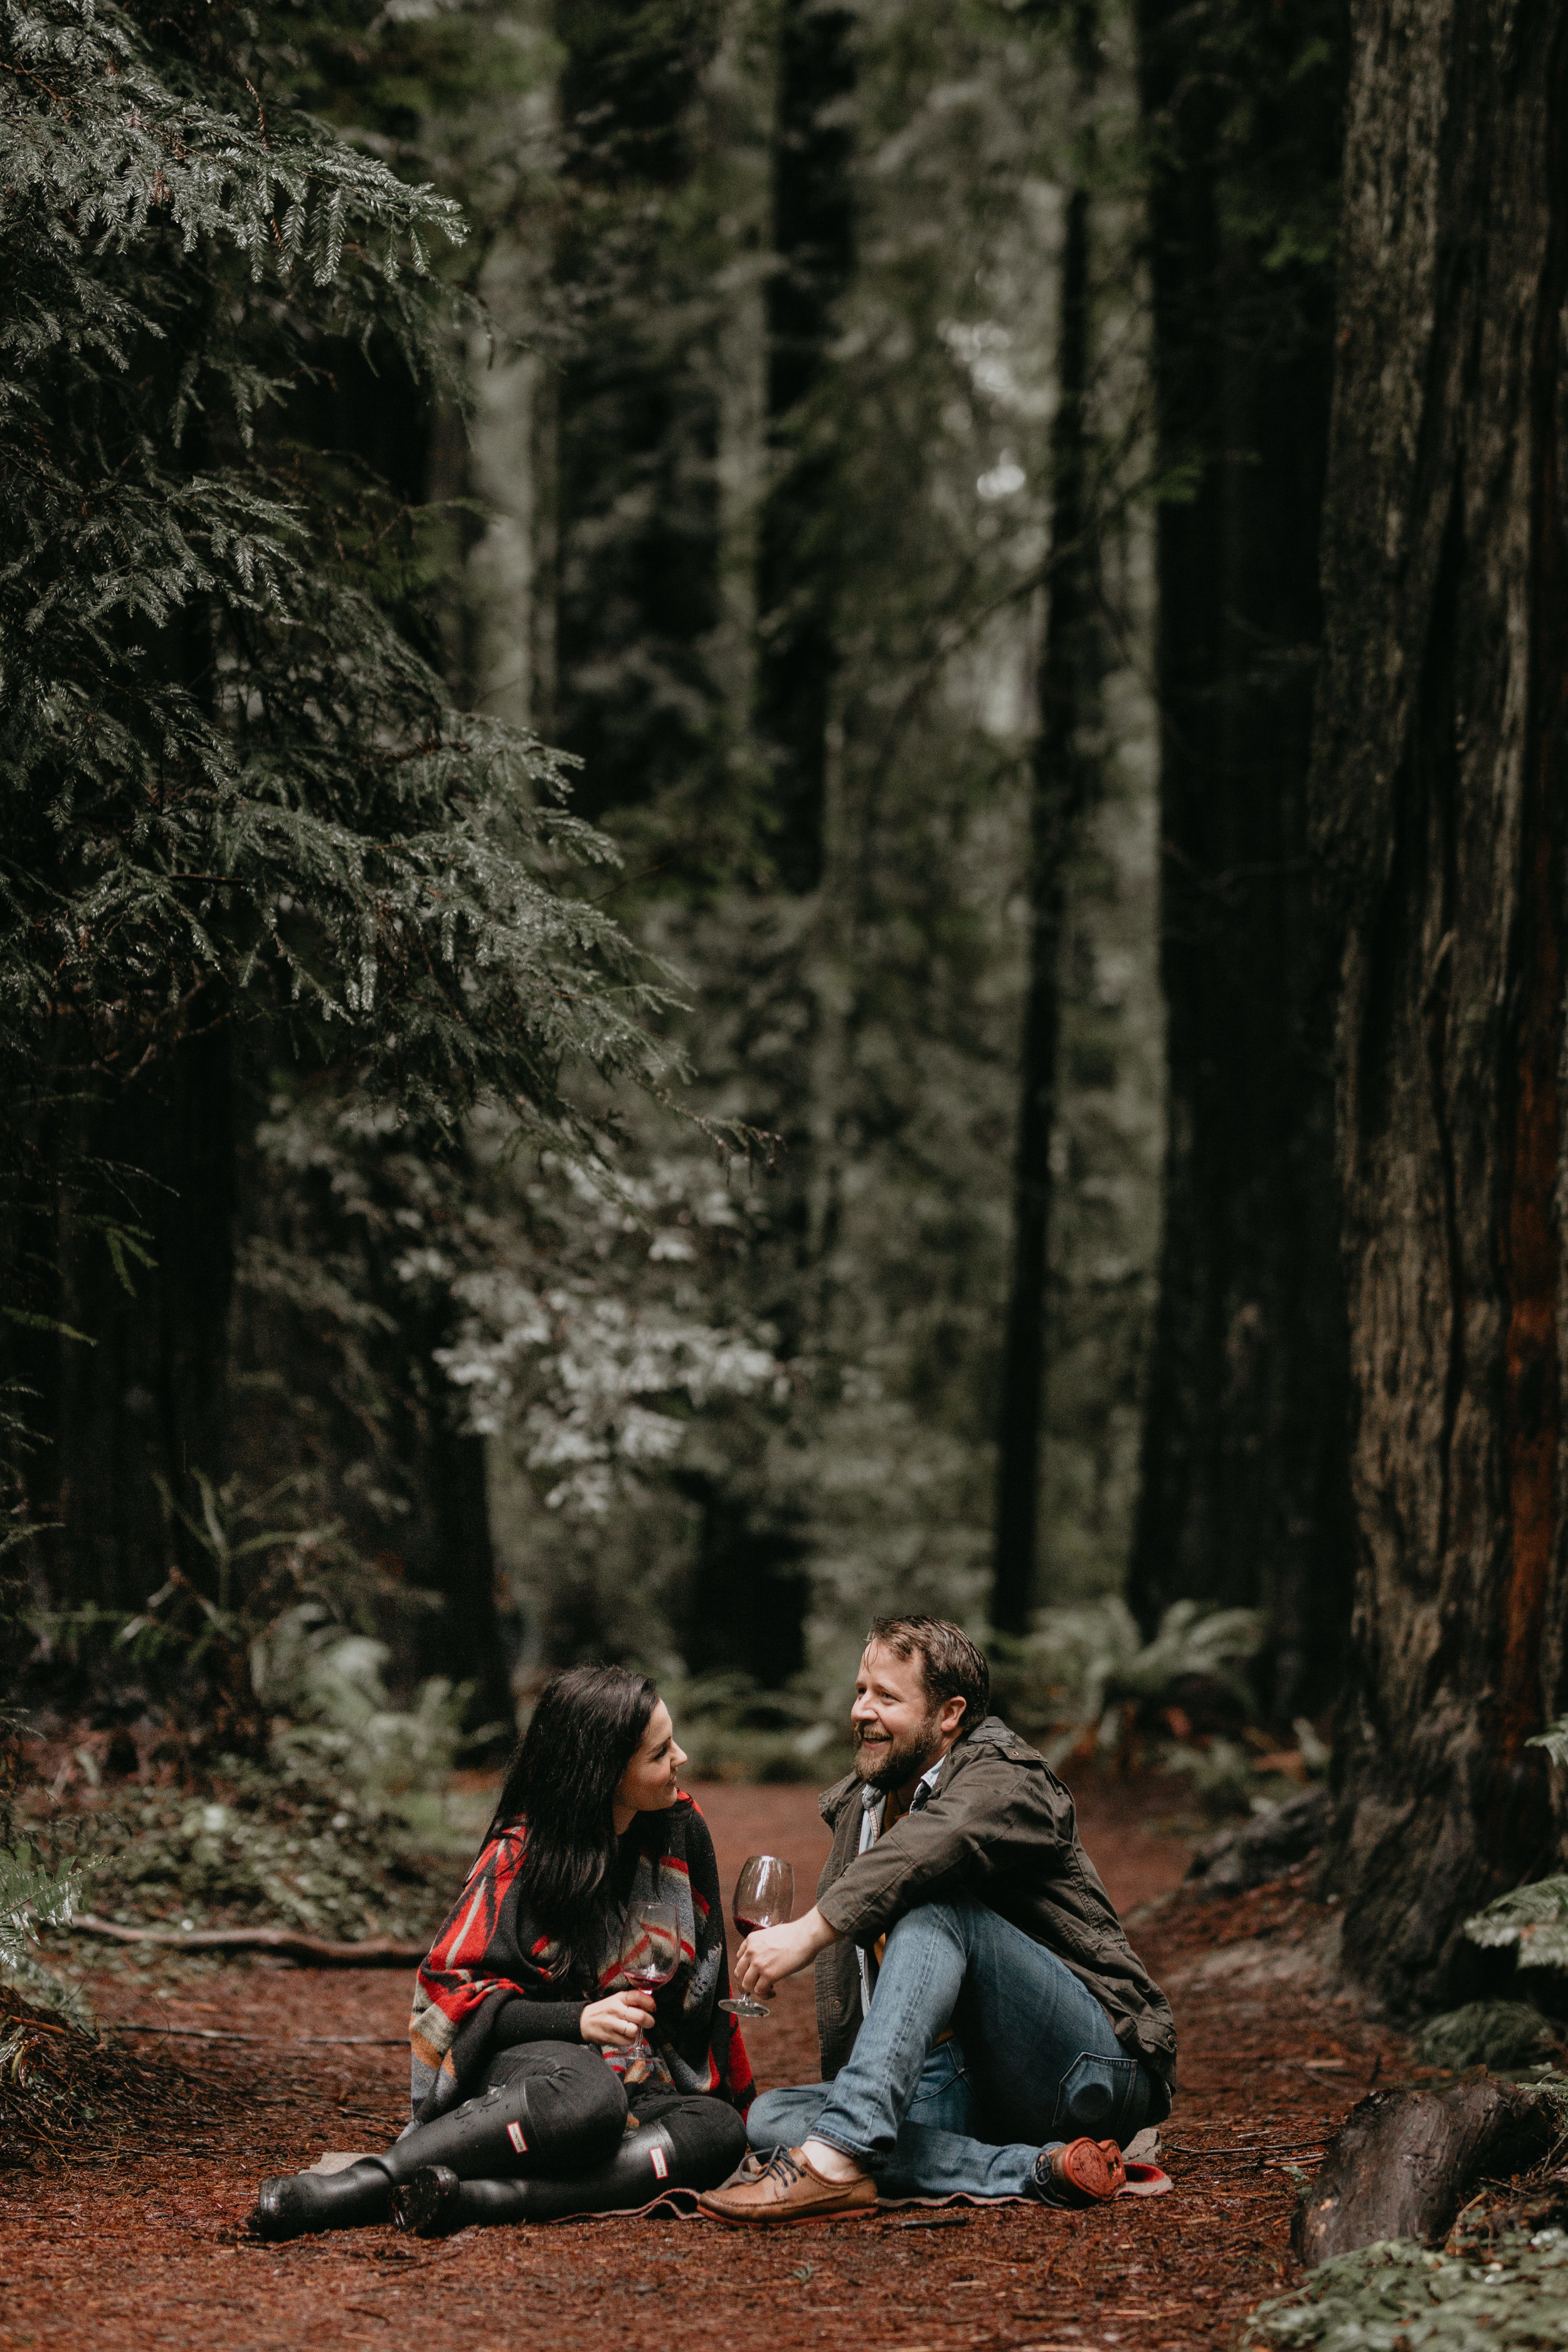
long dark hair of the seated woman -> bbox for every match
[487,1665,658,1983]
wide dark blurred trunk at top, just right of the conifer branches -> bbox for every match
[550,0,724,837]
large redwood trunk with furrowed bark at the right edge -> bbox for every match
[1314,0,1568,2004]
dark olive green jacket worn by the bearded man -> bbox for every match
[816,1715,1175,2089]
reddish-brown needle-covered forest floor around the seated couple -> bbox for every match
[0,1781,1399,2352]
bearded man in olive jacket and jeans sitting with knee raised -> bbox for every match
[703,1616,1175,2223]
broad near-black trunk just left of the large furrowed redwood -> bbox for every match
[1128,0,1349,1719]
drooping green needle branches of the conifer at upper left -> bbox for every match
[0,0,681,1164]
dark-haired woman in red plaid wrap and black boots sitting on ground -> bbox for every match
[252,1665,752,2239]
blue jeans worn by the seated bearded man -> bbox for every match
[745,1903,1150,2197]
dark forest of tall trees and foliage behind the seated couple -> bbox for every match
[0,0,1564,1990]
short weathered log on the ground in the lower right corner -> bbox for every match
[1291,2077,1564,2270]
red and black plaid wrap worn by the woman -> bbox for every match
[409,1797,755,2124]
